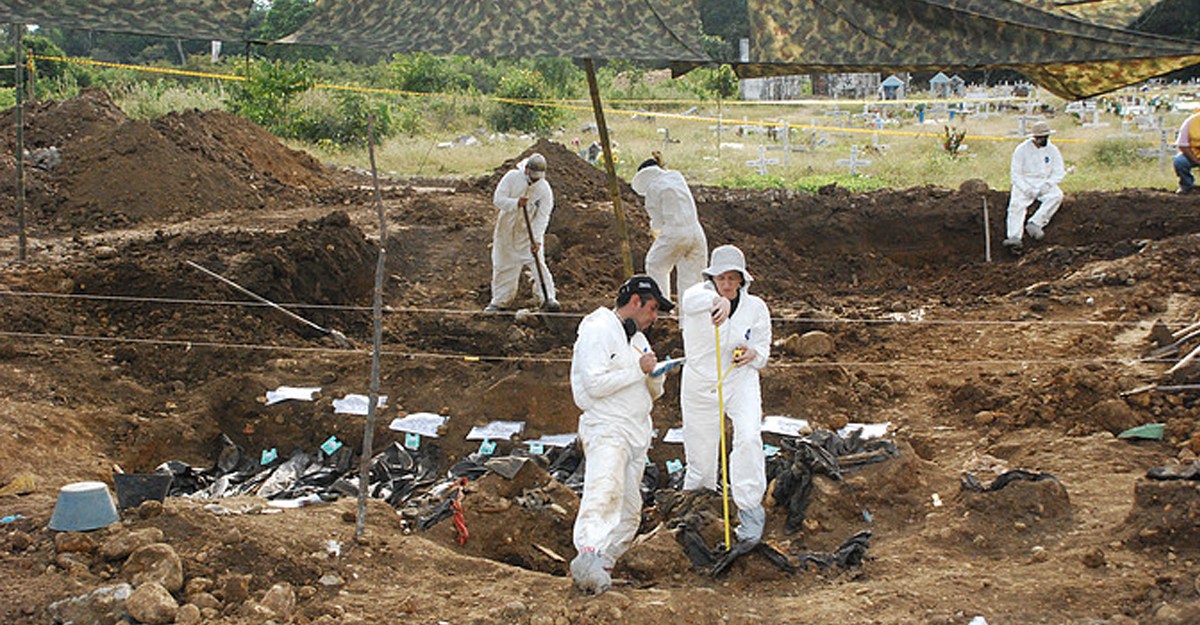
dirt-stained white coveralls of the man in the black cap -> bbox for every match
[571,308,665,567]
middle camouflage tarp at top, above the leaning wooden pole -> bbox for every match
[281,0,709,61]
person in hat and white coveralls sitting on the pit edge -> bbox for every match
[1004,121,1067,252]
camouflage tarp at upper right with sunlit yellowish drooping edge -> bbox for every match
[738,0,1200,100]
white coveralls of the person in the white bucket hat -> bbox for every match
[679,280,770,539]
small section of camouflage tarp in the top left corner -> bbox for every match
[0,0,254,41]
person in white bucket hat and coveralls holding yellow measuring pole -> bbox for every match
[679,245,770,542]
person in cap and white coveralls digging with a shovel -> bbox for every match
[491,161,558,308]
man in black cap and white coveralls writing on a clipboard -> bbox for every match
[571,276,674,594]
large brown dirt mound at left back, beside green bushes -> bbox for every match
[0,90,332,230]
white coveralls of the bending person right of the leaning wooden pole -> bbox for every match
[630,166,708,299]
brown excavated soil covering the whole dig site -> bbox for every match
[0,92,1200,625]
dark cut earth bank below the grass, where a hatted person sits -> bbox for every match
[694,182,1200,304]
